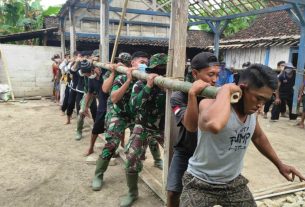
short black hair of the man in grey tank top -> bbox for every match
[239,64,278,91]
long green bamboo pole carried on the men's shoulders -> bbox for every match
[93,62,240,103]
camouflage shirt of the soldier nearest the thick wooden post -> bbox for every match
[129,80,166,130]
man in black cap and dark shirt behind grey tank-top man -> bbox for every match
[167,52,219,207]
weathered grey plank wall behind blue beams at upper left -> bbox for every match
[65,0,170,38]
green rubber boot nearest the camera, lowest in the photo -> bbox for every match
[120,173,139,207]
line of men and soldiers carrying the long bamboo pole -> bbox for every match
[53,51,305,207]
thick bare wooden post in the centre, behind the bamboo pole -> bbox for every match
[163,0,189,201]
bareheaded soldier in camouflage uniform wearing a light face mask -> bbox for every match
[92,52,148,190]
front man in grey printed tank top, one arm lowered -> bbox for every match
[180,64,305,207]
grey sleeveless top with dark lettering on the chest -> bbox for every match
[187,107,256,184]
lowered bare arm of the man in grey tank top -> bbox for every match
[252,122,305,181]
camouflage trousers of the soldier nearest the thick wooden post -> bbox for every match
[125,124,164,173]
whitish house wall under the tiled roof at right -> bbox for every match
[225,46,290,69]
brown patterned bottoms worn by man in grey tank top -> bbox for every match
[180,172,256,207]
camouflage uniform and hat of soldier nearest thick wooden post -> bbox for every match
[126,54,167,173]
